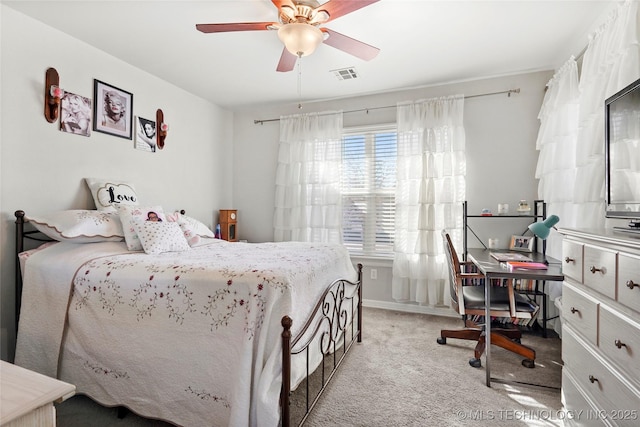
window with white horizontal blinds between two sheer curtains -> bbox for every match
[342,125,397,256]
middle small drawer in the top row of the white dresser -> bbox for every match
[583,245,617,299]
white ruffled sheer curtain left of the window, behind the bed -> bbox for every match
[273,112,342,243]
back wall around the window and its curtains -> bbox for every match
[233,71,553,312]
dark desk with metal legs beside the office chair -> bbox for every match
[467,249,564,387]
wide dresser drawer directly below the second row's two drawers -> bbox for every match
[562,329,640,426]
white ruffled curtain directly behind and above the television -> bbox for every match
[572,0,640,227]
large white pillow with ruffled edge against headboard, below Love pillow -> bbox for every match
[27,209,124,243]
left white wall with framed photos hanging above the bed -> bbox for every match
[0,5,233,360]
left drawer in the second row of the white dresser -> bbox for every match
[562,282,598,345]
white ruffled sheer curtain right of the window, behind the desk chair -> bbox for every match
[392,95,466,306]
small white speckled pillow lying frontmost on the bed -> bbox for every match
[134,220,191,254]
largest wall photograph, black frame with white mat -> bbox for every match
[93,79,133,139]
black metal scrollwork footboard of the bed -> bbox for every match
[280,264,362,427]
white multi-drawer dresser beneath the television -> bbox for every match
[560,229,640,426]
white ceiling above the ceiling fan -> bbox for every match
[2,0,617,110]
